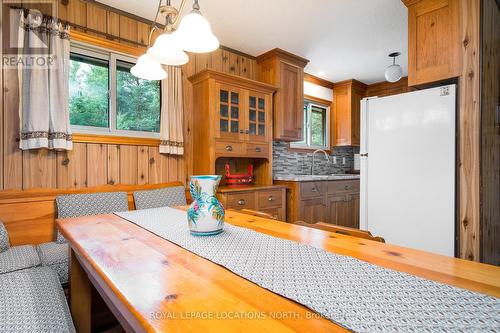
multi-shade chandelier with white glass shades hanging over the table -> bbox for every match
[130,0,219,80]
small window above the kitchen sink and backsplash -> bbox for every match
[290,100,330,149]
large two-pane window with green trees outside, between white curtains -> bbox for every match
[69,45,161,138]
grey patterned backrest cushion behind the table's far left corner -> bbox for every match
[56,192,128,243]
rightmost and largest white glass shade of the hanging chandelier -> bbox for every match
[176,10,219,53]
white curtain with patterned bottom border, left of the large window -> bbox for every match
[17,10,73,150]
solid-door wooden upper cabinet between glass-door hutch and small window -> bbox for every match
[257,49,309,141]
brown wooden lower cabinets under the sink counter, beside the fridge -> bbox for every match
[275,179,359,228]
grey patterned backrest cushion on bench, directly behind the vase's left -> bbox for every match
[134,186,186,209]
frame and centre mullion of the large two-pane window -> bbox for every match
[70,42,162,139]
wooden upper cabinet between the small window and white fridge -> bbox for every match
[331,80,366,146]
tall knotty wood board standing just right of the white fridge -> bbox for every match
[458,0,481,261]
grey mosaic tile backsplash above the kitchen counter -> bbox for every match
[273,141,359,175]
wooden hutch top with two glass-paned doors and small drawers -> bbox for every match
[189,69,276,184]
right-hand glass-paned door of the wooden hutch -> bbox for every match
[247,91,271,141]
